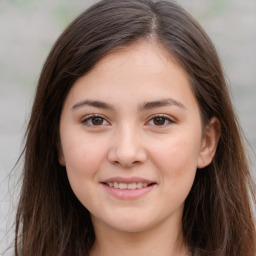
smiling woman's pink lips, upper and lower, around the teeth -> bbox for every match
[100,177,157,200]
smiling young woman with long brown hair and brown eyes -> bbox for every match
[15,0,256,256]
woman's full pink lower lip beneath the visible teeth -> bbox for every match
[101,183,156,199]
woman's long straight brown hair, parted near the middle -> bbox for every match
[15,0,256,256]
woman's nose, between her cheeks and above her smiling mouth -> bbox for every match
[108,126,147,168]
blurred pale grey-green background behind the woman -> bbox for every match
[0,0,256,255]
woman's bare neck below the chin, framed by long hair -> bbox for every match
[90,216,188,256]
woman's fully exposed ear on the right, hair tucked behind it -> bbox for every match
[197,117,221,169]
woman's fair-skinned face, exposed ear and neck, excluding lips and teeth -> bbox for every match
[59,42,218,256]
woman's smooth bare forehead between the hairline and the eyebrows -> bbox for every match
[64,42,198,110]
